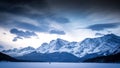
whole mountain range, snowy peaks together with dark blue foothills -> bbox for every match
[2,34,120,62]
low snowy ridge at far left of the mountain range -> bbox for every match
[2,46,35,57]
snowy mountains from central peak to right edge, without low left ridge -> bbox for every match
[38,34,120,57]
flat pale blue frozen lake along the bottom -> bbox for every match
[0,62,120,68]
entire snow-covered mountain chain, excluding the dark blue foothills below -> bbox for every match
[3,34,120,58]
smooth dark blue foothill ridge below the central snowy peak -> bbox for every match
[16,52,79,62]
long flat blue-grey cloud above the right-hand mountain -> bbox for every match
[86,23,120,31]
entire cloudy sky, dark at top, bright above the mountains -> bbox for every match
[0,0,120,48]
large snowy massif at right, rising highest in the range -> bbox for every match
[79,34,120,56]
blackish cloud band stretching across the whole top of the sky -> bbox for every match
[0,0,120,15]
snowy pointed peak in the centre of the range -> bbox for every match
[37,38,69,53]
